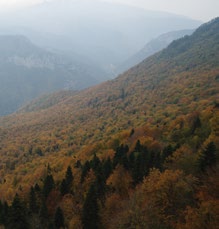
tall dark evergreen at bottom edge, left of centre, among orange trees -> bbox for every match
[82,184,100,229]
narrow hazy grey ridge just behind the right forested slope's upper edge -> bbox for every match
[116,30,194,73]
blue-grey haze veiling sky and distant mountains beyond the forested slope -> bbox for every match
[0,0,216,116]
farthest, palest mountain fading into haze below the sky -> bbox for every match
[0,0,201,75]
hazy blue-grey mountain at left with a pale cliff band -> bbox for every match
[0,35,104,115]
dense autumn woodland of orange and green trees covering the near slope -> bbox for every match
[0,18,219,229]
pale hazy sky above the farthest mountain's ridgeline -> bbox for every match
[0,0,219,21]
